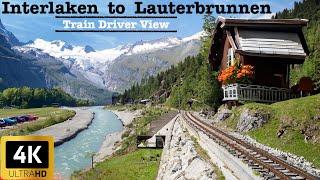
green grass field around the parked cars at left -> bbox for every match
[0,107,75,137]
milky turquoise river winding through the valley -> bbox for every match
[55,107,123,178]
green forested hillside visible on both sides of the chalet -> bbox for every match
[120,0,320,107]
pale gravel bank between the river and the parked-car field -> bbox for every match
[32,108,94,146]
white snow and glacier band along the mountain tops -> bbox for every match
[15,32,203,70]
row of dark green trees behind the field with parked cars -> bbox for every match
[0,87,89,108]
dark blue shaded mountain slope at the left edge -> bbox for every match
[0,18,112,104]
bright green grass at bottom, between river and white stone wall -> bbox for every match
[72,149,162,180]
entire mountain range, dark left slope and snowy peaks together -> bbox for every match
[0,15,202,104]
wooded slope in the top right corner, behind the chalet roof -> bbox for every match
[276,0,320,90]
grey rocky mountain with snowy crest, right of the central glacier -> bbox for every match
[105,36,201,92]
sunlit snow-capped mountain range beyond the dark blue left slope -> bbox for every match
[14,32,202,92]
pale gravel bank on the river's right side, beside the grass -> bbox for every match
[94,110,141,163]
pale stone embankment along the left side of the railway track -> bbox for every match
[157,121,214,180]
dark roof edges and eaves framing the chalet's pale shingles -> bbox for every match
[209,17,309,69]
